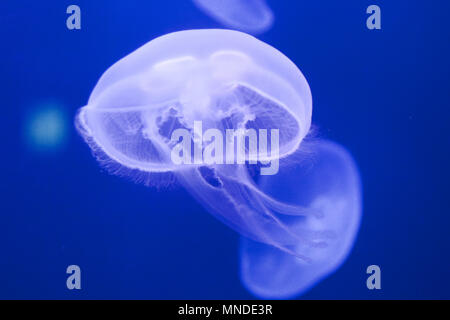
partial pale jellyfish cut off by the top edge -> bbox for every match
[193,0,274,34]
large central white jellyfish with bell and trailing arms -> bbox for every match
[77,29,362,298]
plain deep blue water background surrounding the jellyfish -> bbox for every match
[0,0,450,299]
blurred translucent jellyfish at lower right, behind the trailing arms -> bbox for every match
[240,141,361,298]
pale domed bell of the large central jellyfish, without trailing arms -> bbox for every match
[77,29,312,172]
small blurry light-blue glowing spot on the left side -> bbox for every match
[24,102,69,153]
